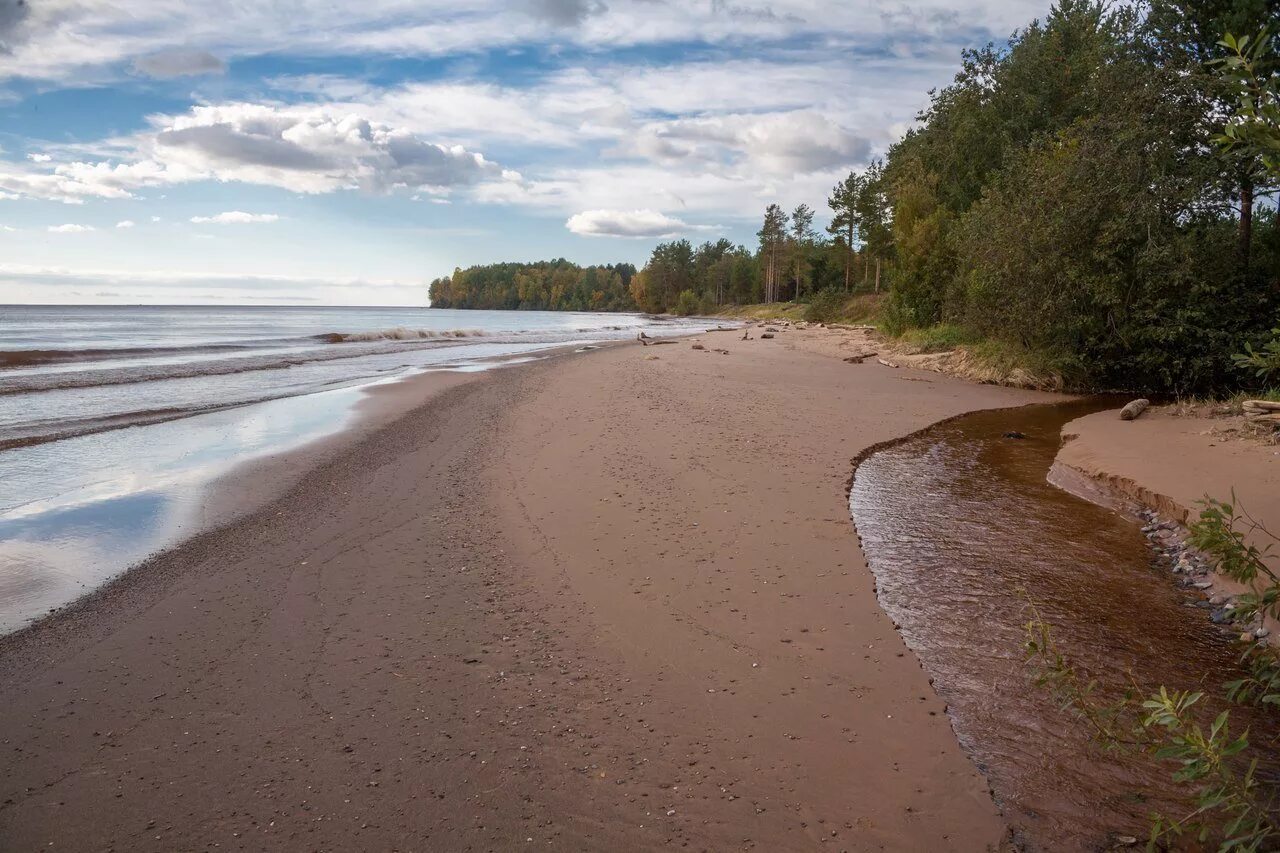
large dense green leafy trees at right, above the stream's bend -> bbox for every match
[882,0,1280,392]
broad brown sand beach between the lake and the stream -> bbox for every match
[0,325,1043,850]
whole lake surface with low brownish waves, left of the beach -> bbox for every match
[0,306,707,633]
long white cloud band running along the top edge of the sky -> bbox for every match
[0,0,1048,88]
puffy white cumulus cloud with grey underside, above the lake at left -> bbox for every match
[0,104,502,204]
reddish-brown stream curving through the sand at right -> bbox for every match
[850,398,1269,850]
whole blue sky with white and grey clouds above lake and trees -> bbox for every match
[0,0,1048,305]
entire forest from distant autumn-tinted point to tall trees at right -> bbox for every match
[431,0,1280,392]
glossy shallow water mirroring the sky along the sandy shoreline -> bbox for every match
[0,357,531,633]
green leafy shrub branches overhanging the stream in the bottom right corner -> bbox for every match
[1025,494,1280,850]
